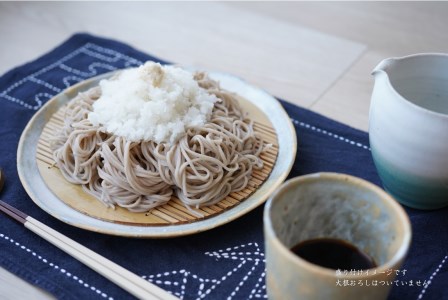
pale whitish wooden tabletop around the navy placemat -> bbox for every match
[0,2,448,299]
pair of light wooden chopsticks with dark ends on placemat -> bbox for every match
[0,200,177,299]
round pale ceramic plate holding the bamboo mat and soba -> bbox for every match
[17,72,297,238]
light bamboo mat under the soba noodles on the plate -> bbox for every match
[36,99,278,226]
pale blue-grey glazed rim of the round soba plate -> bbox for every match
[17,70,297,238]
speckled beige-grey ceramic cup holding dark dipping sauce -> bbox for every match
[264,173,411,300]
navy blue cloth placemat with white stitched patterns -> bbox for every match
[0,34,448,299]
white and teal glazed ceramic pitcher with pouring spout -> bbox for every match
[369,53,448,209]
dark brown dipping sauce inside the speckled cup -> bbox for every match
[291,238,376,270]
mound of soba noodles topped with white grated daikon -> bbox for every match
[51,62,267,212]
